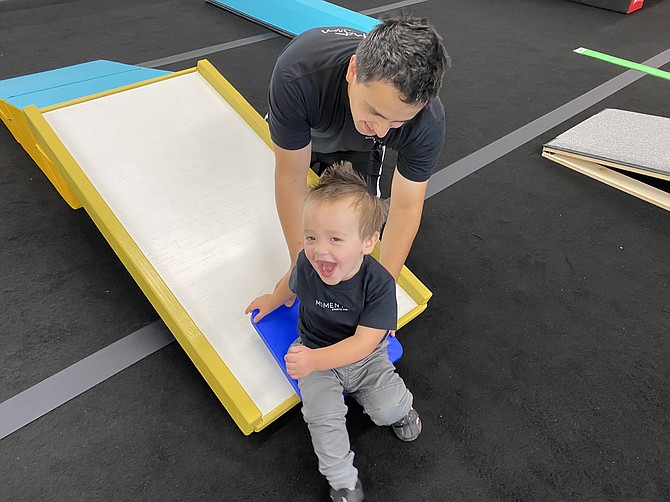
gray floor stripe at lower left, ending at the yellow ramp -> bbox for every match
[0,321,174,439]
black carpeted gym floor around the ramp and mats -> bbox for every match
[0,0,670,502]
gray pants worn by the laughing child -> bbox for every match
[295,338,413,490]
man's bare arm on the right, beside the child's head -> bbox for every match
[379,169,428,281]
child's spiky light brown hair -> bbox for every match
[305,161,388,239]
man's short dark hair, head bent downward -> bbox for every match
[356,16,450,105]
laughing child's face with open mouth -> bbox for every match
[302,200,379,286]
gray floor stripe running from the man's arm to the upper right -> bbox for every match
[426,49,670,199]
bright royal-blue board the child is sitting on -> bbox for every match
[251,300,403,396]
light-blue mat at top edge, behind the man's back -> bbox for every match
[207,0,379,37]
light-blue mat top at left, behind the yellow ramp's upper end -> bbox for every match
[0,60,171,109]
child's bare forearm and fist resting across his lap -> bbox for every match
[284,326,386,378]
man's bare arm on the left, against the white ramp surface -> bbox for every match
[273,143,312,264]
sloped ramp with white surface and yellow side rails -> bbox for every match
[25,61,430,434]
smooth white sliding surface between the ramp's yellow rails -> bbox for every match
[44,73,293,414]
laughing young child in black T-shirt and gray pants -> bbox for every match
[246,163,421,501]
